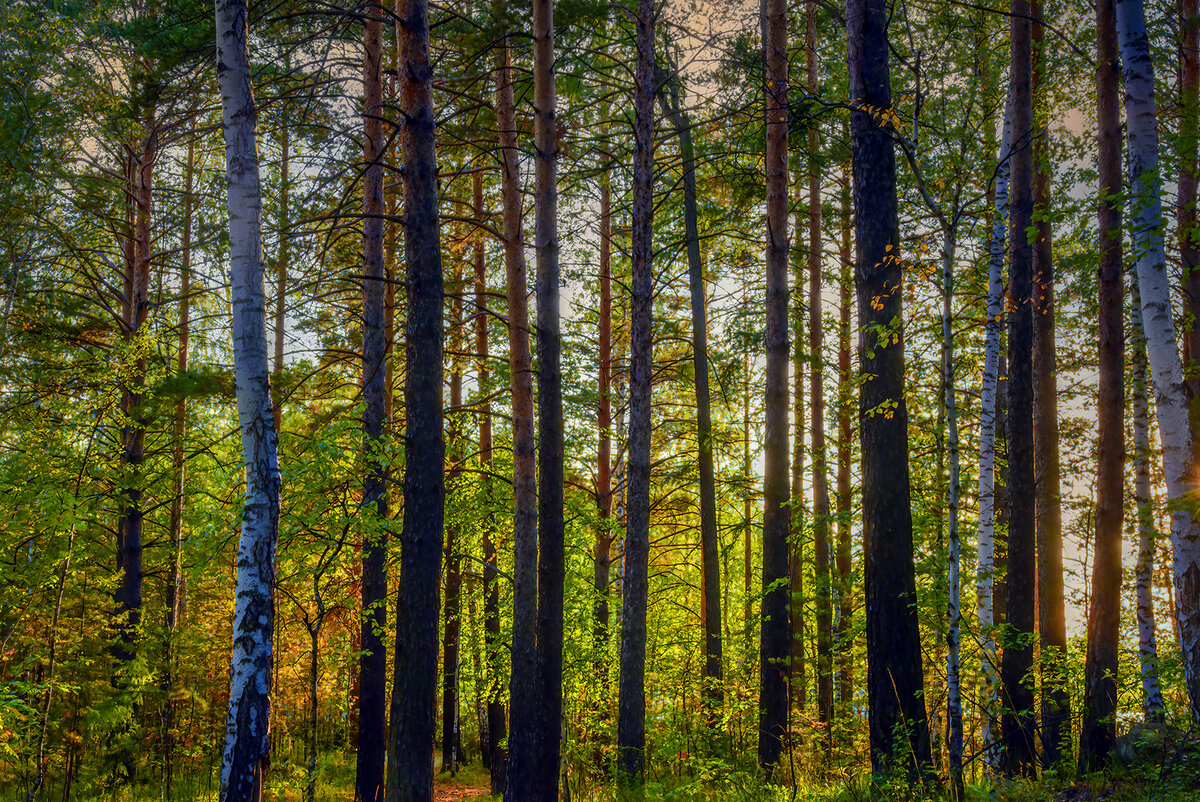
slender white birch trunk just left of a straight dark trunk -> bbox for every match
[976,89,1013,770]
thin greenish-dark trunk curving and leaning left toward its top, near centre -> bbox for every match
[657,56,725,728]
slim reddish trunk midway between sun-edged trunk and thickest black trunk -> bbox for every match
[805,0,833,755]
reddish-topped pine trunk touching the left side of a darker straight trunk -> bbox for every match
[496,0,539,787]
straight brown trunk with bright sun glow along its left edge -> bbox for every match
[758,0,792,770]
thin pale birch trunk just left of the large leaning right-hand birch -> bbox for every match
[1117,268,1174,722]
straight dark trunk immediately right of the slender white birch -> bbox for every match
[1000,0,1037,774]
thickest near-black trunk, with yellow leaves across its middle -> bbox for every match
[846,0,932,776]
